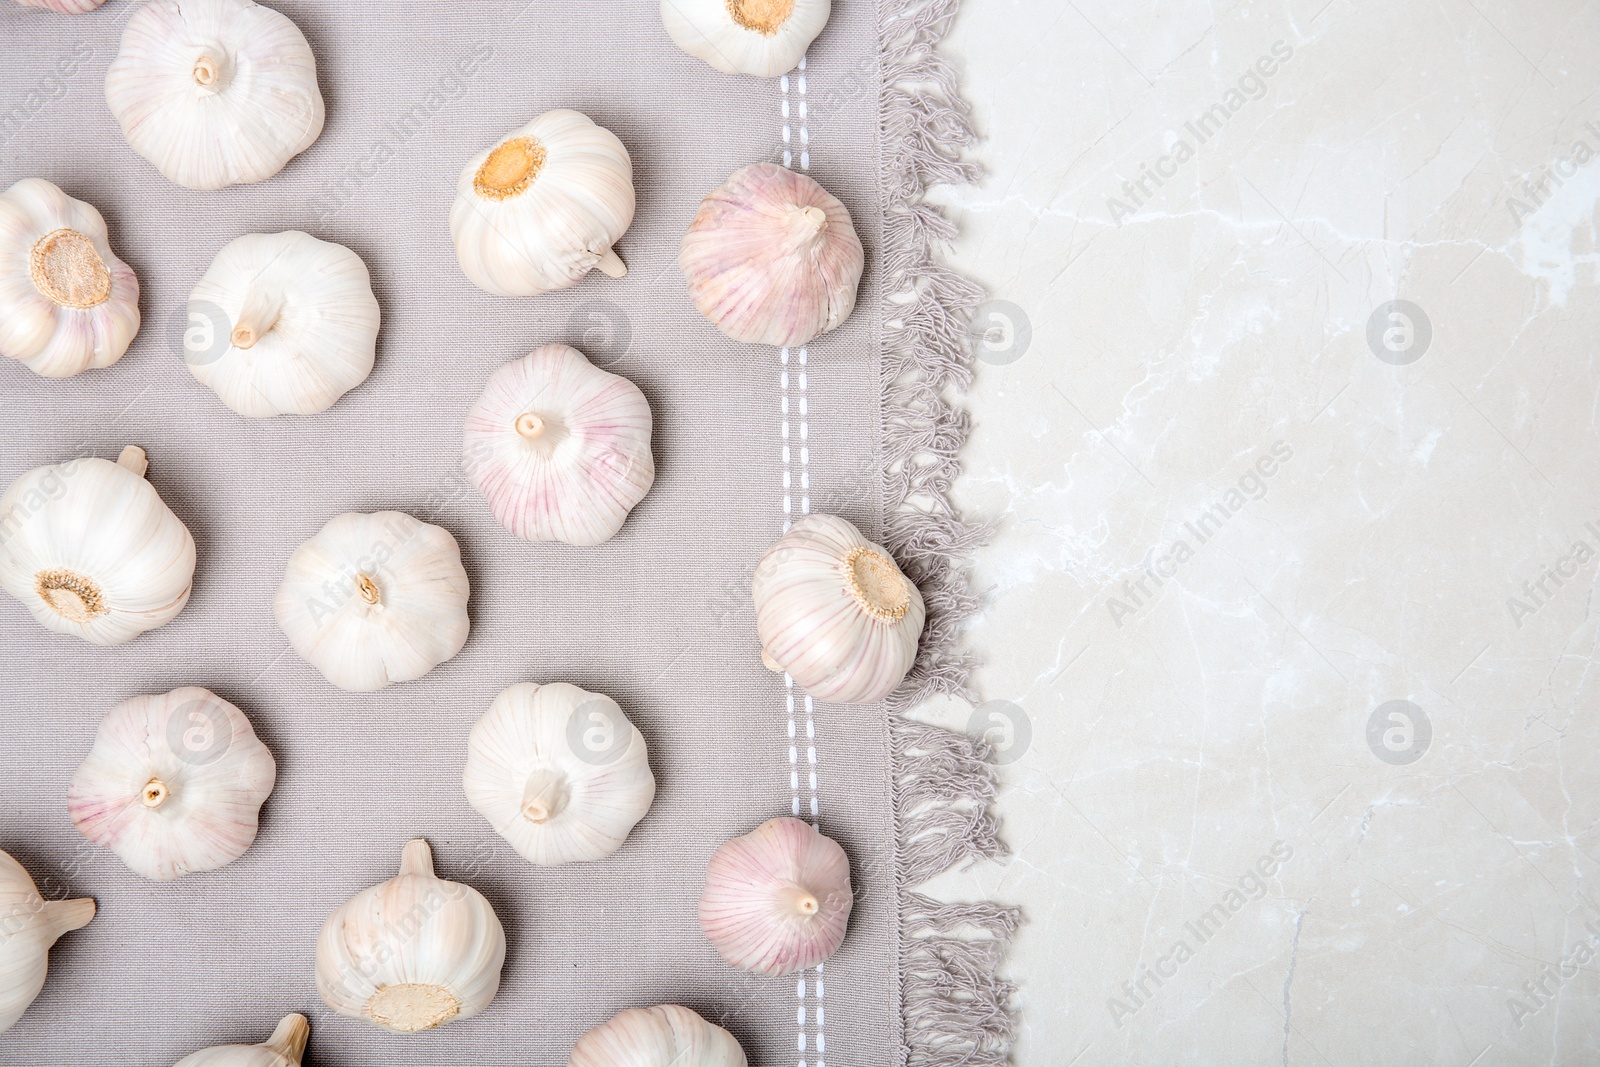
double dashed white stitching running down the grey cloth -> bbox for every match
[778,56,827,1067]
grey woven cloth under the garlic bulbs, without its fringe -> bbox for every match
[0,0,902,1067]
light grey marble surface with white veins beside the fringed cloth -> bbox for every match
[933,0,1600,1067]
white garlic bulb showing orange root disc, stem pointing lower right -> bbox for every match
[450,110,634,296]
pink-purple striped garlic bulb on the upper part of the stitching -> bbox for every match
[678,163,866,347]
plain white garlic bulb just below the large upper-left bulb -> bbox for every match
[184,230,379,418]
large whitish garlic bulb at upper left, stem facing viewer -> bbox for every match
[106,0,325,189]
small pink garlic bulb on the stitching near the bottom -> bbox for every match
[701,816,851,977]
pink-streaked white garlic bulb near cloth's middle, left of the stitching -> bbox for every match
[462,344,656,544]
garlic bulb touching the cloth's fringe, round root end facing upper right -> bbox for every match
[752,515,926,704]
